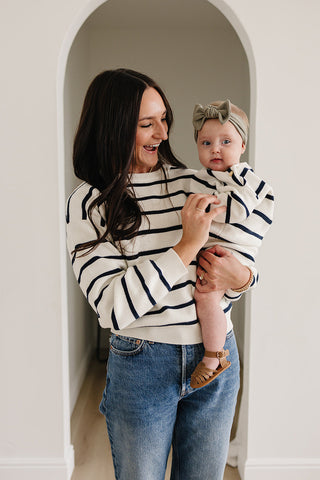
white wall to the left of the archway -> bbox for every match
[0,1,79,480]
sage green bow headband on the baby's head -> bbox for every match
[192,100,248,144]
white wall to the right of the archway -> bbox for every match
[224,1,320,480]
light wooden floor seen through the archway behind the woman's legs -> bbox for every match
[71,359,240,480]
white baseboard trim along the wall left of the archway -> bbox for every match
[0,445,74,480]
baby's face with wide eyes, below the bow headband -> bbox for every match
[197,118,246,172]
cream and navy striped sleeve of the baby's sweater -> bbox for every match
[207,163,273,223]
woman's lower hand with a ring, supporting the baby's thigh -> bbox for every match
[196,245,250,293]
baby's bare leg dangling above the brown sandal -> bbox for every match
[194,290,227,370]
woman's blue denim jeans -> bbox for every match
[100,331,239,480]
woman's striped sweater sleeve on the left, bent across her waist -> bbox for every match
[67,188,187,330]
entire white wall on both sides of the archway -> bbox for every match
[0,0,320,480]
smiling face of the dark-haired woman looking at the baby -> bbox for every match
[132,87,168,173]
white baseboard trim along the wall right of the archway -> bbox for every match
[243,458,320,480]
